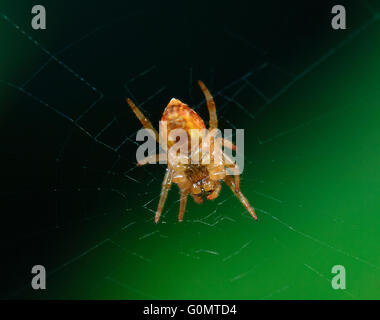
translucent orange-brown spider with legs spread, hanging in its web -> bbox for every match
[127,81,257,223]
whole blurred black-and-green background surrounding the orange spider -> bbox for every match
[0,1,380,299]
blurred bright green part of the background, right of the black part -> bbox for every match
[91,24,380,299]
